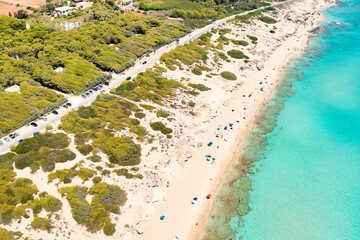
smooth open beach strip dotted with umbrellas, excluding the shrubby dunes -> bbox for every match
[135,0,334,240]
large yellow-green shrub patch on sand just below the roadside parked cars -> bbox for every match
[59,94,146,166]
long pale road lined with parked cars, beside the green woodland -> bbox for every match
[0,0,296,154]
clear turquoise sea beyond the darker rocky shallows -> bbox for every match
[235,0,360,240]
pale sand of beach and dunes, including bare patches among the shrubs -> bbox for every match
[1,0,335,240]
